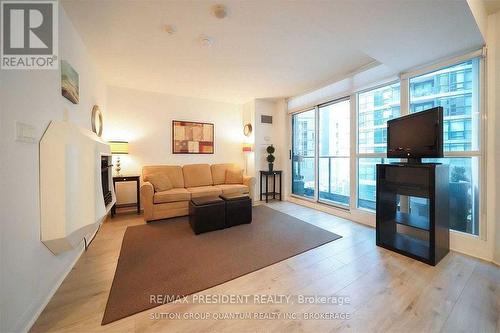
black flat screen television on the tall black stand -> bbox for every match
[387,106,443,161]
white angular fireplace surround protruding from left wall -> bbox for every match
[40,121,116,254]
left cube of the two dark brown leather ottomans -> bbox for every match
[189,196,226,235]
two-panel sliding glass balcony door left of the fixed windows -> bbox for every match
[292,98,351,207]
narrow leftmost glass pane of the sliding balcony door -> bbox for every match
[292,109,316,198]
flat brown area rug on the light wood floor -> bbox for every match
[102,206,341,325]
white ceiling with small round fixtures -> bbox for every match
[63,0,484,103]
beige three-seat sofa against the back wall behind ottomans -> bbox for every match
[141,163,255,221]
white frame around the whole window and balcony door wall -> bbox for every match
[288,49,488,239]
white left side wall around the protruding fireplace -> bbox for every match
[0,6,106,332]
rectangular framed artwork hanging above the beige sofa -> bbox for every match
[172,120,214,154]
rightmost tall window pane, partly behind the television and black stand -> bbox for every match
[409,58,481,235]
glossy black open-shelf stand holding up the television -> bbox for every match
[376,163,450,266]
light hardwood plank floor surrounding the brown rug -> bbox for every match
[31,202,500,332]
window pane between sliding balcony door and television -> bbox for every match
[357,82,400,210]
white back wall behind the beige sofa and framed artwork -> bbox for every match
[104,87,244,203]
